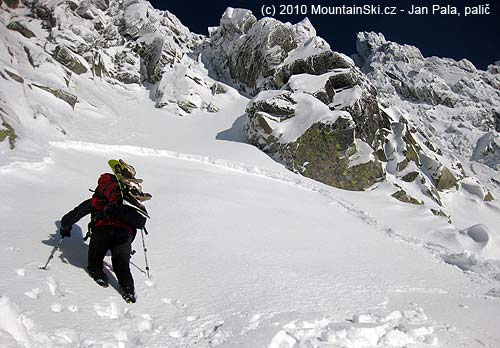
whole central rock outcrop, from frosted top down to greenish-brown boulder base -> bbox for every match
[210,9,385,190]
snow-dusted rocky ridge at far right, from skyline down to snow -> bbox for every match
[354,33,500,204]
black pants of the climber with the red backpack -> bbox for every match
[88,226,134,292]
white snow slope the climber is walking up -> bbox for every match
[0,4,500,348]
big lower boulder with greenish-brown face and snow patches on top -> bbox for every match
[246,91,384,190]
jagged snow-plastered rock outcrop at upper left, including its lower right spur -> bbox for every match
[0,0,227,115]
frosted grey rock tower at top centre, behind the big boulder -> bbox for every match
[206,8,324,94]
